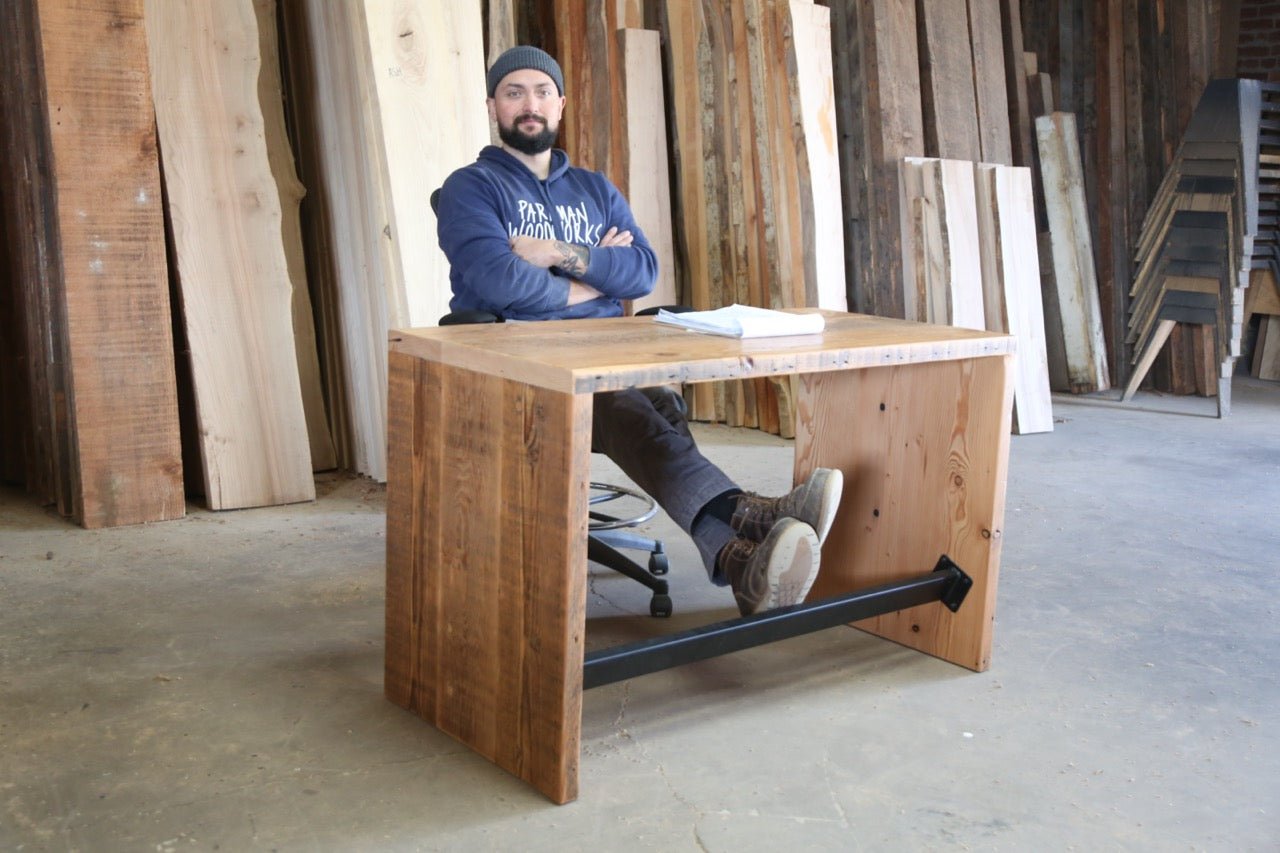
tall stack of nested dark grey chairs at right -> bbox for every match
[1124,79,1261,415]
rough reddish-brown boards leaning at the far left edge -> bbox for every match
[0,0,186,528]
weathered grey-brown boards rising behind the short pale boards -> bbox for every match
[831,0,1027,318]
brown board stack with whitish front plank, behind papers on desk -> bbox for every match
[662,0,847,435]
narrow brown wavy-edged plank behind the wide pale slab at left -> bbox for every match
[253,0,338,471]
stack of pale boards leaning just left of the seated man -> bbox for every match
[284,0,489,480]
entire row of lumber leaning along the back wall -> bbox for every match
[0,0,1280,525]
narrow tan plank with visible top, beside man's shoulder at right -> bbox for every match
[618,29,680,310]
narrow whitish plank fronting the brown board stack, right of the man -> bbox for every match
[791,0,849,311]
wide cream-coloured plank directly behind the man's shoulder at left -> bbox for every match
[364,0,489,327]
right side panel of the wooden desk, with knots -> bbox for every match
[796,356,1012,671]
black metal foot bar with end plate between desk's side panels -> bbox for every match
[582,555,973,688]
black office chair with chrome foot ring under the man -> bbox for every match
[430,190,692,617]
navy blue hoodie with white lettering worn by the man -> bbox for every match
[436,145,658,320]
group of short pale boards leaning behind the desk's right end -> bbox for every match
[901,158,1053,434]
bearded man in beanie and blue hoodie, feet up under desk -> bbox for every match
[438,46,844,615]
